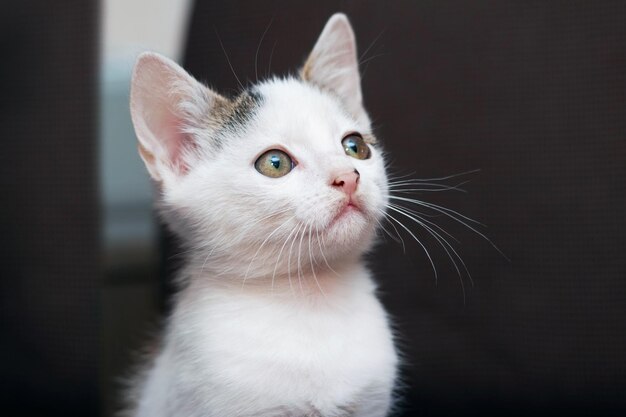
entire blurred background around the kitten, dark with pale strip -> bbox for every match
[0,0,626,417]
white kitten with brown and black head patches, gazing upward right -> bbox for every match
[129,14,398,417]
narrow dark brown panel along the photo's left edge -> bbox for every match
[0,0,102,417]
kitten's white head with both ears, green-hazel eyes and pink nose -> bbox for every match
[131,14,387,279]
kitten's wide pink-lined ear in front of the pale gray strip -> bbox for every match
[130,52,226,181]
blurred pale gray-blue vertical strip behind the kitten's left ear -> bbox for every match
[100,0,191,250]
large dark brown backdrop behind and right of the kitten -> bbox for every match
[173,0,626,416]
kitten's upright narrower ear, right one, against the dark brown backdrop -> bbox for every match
[301,13,367,121]
